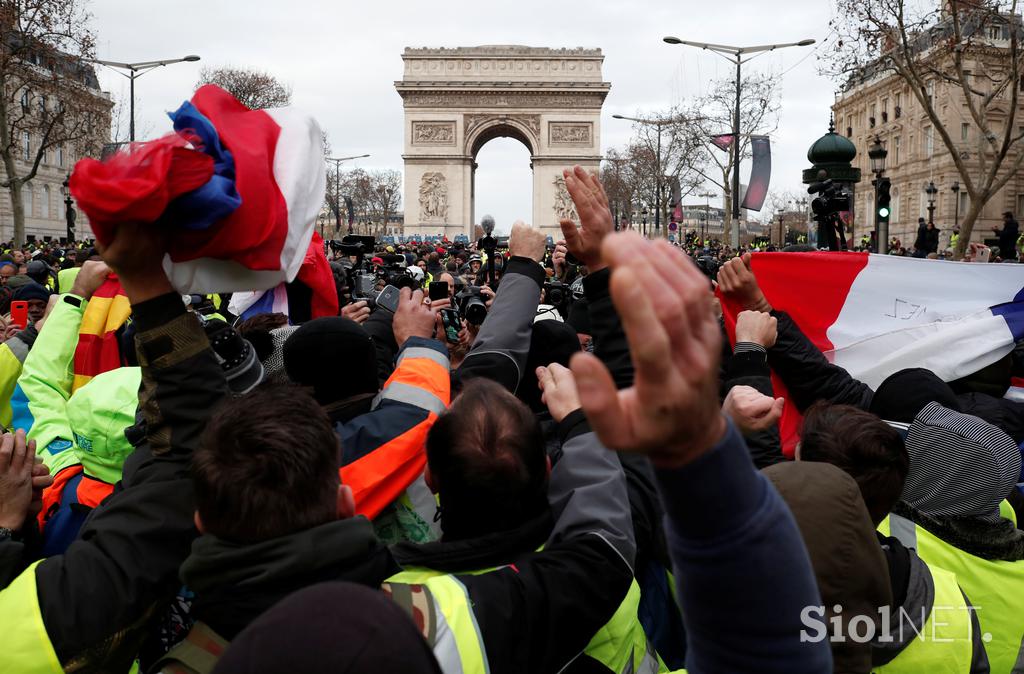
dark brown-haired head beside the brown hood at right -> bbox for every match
[800,403,910,526]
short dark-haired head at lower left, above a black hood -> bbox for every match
[193,384,340,543]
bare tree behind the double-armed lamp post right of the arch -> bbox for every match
[690,74,778,241]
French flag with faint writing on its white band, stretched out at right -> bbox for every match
[722,252,1024,455]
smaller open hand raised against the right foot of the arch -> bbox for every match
[558,166,615,272]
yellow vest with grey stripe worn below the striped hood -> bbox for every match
[879,514,1024,673]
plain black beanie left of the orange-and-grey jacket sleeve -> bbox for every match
[284,317,380,406]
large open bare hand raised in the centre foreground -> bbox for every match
[570,233,726,467]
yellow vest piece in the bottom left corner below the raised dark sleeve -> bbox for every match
[0,561,63,674]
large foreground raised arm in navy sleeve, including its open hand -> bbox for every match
[571,233,831,672]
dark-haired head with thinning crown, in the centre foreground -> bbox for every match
[427,379,548,540]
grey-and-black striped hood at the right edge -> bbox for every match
[901,403,1021,522]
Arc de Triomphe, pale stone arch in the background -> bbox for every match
[395,45,611,239]
